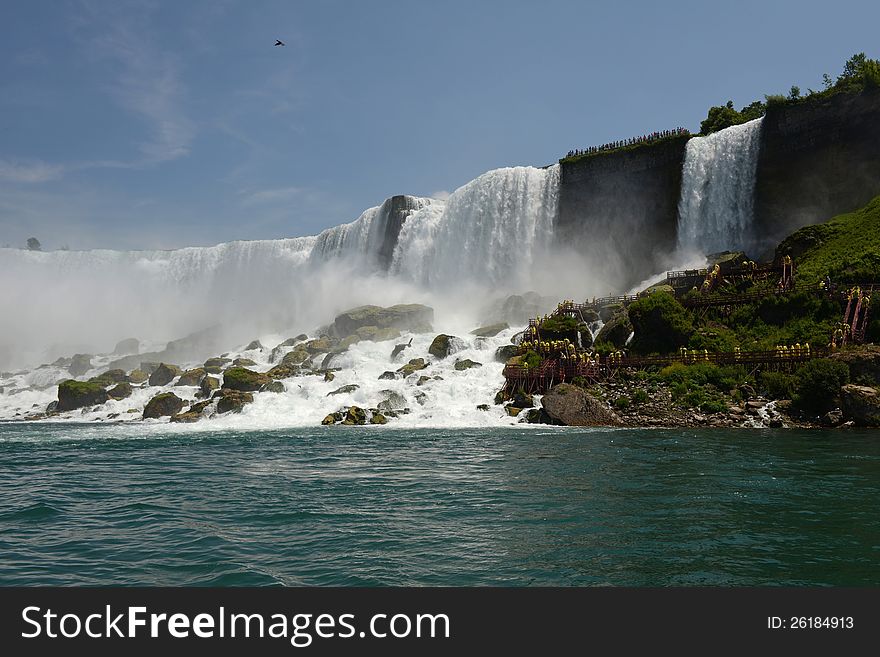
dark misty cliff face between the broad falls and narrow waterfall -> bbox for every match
[556,138,687,288]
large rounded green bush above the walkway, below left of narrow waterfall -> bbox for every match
[628,292,694,354]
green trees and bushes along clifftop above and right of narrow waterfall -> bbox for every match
[700,52,880,135]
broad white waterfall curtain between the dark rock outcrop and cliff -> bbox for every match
[391,165,559,288]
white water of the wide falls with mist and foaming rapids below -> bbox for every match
[0,166,559,430]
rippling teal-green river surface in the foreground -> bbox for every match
[0,423,880,586]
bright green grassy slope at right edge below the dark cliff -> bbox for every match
[777,196,880,284]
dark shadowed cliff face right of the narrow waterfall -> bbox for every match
[755,90,880,253]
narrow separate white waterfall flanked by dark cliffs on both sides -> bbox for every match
[678,119,762,254]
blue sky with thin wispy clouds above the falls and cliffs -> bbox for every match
[0,0,880,249]
